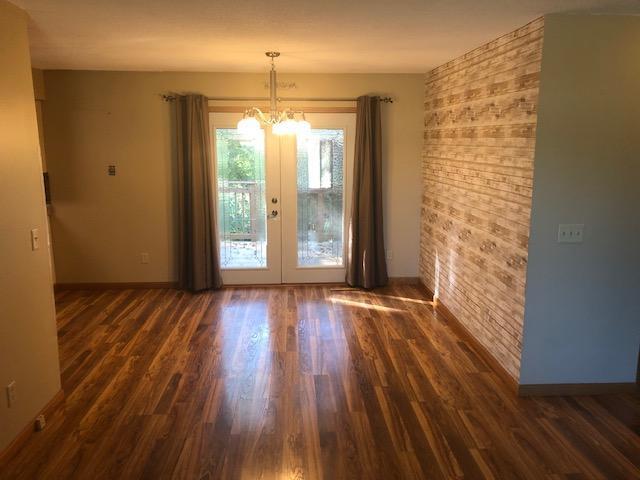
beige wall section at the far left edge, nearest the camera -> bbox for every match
[0,0,60,450]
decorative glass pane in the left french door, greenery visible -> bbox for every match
[215,128,267,269]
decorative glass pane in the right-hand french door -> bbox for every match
[297,129,344,267]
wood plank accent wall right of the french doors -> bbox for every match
[420,18,544,380]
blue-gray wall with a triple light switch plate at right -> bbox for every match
[520,15,640,384]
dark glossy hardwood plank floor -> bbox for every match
[0,286,640,480]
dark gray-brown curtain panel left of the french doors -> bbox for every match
[176,95,222,292]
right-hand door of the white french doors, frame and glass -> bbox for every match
[280,112,356,283]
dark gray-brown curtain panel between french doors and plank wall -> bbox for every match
[347,96,388,288]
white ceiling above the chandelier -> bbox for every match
[10,0,640,73]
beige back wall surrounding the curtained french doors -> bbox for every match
[45,71,423,283]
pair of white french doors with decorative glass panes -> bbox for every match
[210,112,355,285]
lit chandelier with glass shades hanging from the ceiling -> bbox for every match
[238,52,311,136]
